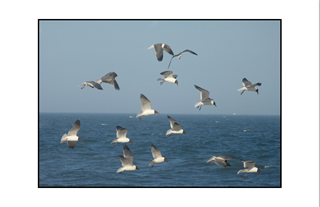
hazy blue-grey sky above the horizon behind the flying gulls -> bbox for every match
[39,20,281,115]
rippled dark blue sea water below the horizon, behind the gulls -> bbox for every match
[39,113,281,187]
